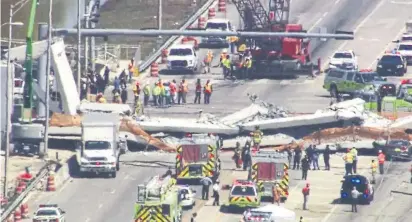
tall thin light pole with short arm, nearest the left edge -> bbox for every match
[3,5,23,197]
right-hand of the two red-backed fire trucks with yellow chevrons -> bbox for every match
[249,151,289,201]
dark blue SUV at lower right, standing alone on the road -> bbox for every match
[340,175,375,204]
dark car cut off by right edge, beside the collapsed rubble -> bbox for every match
[382,140,412,160]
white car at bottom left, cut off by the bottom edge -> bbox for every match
[33,204,66,222]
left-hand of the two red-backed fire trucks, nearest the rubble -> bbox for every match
[176,134,220,180]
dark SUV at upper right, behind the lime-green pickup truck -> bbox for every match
[376,54,407,76]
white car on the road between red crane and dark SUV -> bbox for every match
[329,50,358,70]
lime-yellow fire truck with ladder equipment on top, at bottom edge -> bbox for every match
[134,175,182,222]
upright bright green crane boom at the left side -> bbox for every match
[22,0,38,123]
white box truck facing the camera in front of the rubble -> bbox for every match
[76,113,127,178]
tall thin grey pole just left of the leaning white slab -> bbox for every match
[44,0,53,157]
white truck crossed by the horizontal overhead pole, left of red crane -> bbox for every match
[200,18,234,48]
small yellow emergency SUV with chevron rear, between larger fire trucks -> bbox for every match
[229,180,260,209]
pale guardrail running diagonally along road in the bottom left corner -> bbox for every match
[0,161,54,221]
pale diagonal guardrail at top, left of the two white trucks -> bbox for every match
[139,0,215,73]
